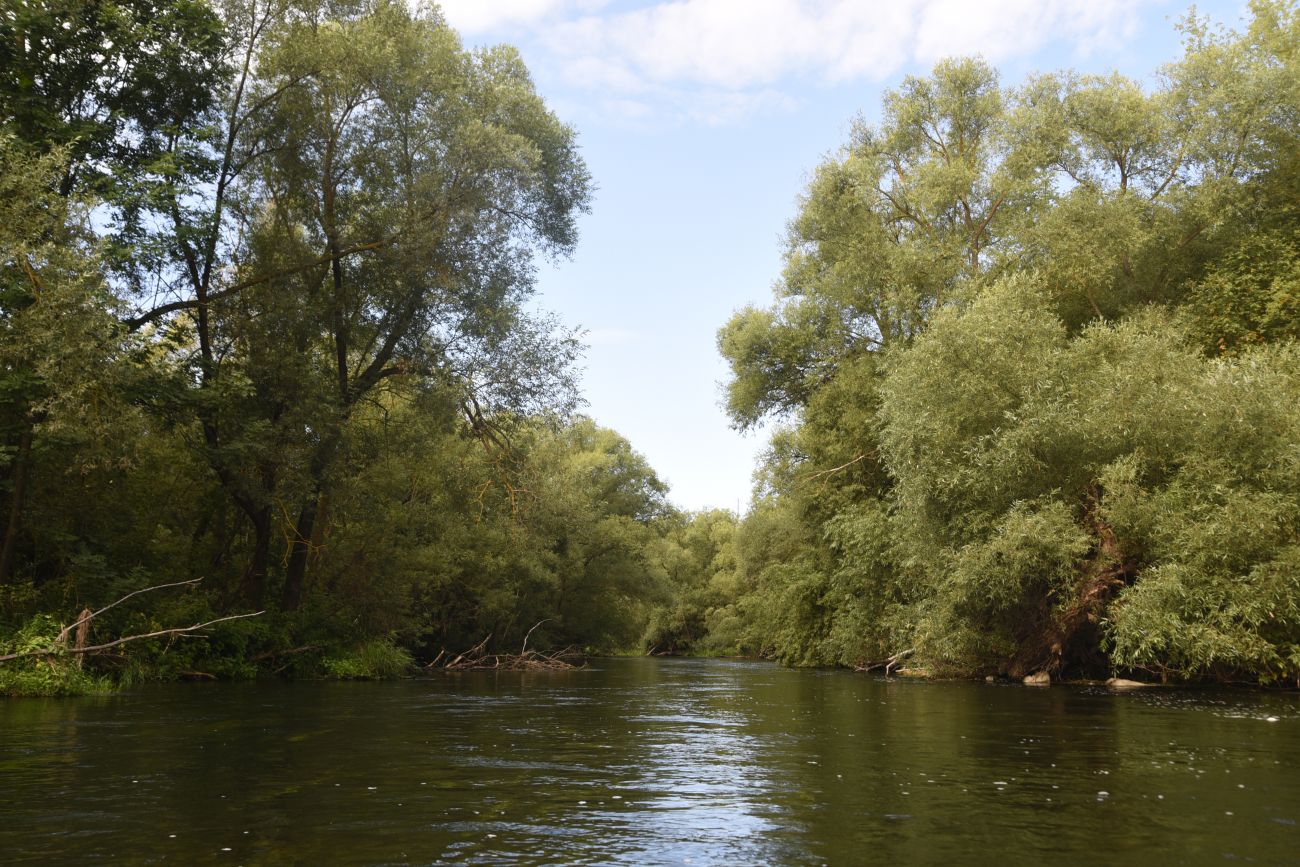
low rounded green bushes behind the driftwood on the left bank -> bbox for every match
[291,394,667,655]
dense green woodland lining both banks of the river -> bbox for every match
[0,0,1300,694]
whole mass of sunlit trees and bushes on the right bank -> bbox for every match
[697,0,1300,681]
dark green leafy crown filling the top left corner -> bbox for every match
[0,0,225,250]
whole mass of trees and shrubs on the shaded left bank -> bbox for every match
[0,0,676,681]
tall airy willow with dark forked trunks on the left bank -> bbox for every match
[124,0,589,610]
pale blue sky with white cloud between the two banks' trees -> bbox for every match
[439,0,1245,511]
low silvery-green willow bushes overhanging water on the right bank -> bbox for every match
[883,278,1300,676]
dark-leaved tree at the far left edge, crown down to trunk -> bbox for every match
[0,0,221,581]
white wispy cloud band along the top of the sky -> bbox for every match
[442,0,1139,123]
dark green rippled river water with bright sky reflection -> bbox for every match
[0,659,1300,867]
